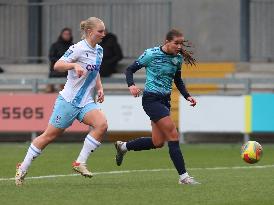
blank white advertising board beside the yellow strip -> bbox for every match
[179,96,245,133]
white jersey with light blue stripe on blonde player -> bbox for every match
[60,39,103,107]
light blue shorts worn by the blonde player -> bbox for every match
[49,95,100,129]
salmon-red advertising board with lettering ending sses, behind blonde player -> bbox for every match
[0,93,89,132]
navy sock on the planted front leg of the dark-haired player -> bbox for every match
[168,141,186,175]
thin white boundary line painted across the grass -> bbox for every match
[0,164,274,181]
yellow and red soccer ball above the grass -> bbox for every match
[241,141,263,164]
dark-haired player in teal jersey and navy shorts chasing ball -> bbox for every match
[115,29,199,184]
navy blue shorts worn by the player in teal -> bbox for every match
[142,91,170,122]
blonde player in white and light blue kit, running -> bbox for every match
[15,17,107,185]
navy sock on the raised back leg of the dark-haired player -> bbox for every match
[126,137,155,151]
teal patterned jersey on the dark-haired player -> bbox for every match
[137,47,183,94]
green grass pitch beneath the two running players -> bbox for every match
[0,143,274,205]
